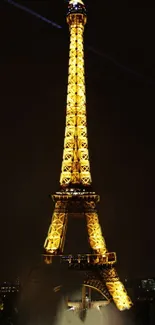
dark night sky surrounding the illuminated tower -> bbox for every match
[0,0,155,279]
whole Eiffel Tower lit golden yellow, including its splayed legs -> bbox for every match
[44,0,132,311]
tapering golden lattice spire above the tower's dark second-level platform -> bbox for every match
[60,1,91,187]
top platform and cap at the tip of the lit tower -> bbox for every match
[67,0,87,25]
